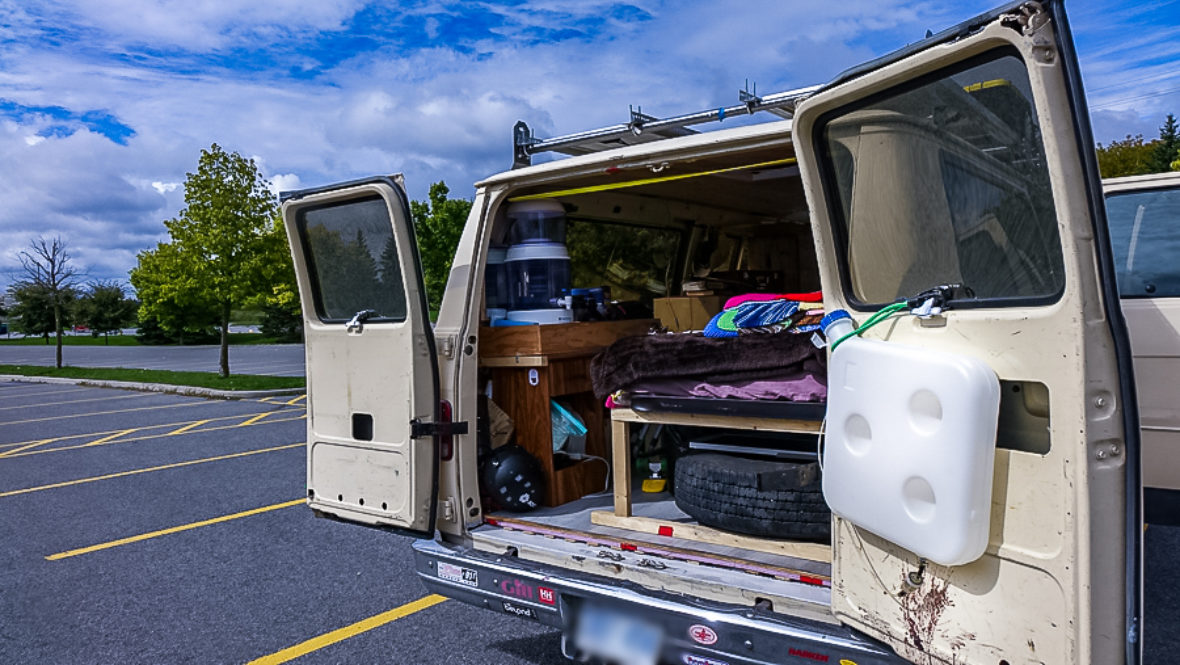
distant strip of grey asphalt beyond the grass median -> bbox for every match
[0,344,303,376]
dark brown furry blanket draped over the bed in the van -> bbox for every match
[590,333,827,400]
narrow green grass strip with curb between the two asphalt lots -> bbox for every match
[0,364,307,390]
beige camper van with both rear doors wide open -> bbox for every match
[276,1,1142,665]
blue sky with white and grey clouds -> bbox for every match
[0,0,1180,287]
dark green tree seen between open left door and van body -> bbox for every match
[410,180,471,311]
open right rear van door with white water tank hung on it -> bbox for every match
[794,1,1141,665]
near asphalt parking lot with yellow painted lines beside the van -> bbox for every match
[0,383,566,665]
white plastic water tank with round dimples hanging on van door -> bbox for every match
[824,310,999,566]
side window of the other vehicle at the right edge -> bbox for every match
[1106,189,1180,298]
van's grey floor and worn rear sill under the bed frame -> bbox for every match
[471,492,833,623]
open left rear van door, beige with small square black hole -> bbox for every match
[283,178,439,535]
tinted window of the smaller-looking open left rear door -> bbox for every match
[296,196,406,323]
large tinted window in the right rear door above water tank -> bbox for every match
[817,51,1064,307]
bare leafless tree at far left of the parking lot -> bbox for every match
[13,237,78,367]
